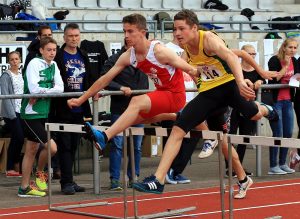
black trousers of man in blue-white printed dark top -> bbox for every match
[55,113,83,186]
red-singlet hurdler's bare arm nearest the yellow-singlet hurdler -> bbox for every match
[154,44,198,77]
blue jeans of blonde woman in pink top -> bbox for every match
[269,100,294,168]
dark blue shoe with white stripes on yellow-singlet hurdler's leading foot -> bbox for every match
[132,175,165,194]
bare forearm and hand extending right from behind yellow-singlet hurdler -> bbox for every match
[231,49,278,80]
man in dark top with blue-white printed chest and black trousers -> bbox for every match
[52,23,92,195]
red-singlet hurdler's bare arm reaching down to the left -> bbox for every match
[68,49,130,108]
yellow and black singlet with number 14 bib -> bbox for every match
[184,30,234,92]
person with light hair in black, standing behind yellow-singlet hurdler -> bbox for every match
[226,44,263,176]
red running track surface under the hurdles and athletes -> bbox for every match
[0,179,300,219]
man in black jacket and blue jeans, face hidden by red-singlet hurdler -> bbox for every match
[101,42,149,190]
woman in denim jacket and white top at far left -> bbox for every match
[0,51,24,177]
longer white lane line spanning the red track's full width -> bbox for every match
[0,182,300,217]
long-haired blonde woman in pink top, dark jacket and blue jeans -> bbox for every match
[268,38,298,175]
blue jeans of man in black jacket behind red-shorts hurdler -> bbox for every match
[109,114,144,180]
